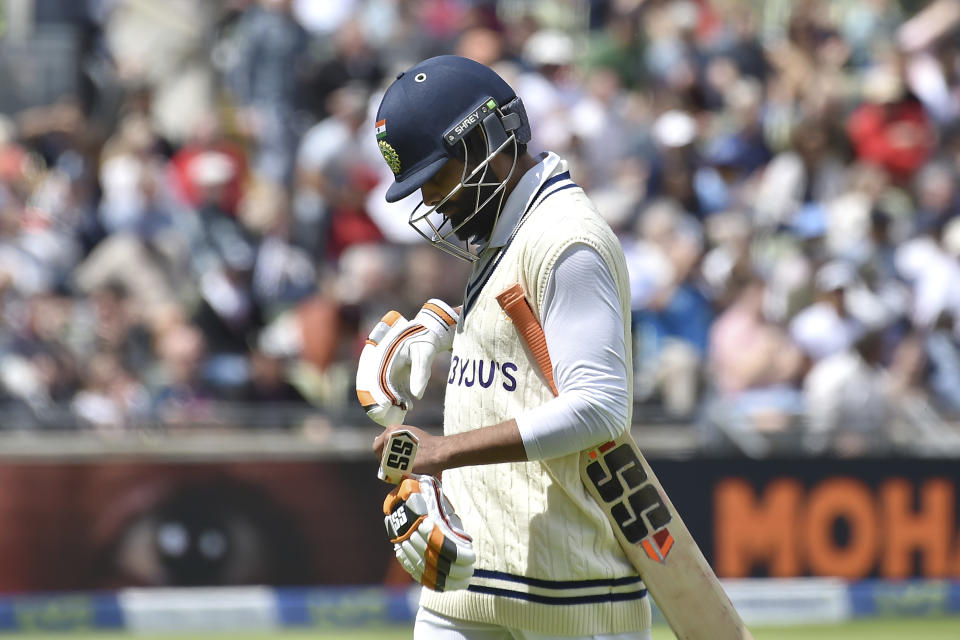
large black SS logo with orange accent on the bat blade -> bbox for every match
[586,442,673,562]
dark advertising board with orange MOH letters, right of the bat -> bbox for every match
[636,458,960,579]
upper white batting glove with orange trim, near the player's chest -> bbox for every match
[357,298,460,426]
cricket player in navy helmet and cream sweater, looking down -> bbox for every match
[357,56,648,640]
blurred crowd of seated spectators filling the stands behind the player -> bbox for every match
[0,0,960,454]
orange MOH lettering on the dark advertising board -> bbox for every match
[713,476,960,579]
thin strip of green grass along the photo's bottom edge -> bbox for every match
[9,617,960,640]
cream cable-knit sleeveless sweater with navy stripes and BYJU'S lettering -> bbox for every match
[421,162,650,635]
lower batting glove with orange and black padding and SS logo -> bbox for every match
[383,475,476,591]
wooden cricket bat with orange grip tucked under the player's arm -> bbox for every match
[497,284,753,640]
